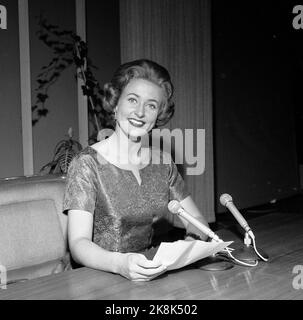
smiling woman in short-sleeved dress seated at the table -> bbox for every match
[64,60,211,281]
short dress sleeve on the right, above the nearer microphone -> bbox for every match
[169,154,189,201]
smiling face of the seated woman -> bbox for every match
[116,79,164,139]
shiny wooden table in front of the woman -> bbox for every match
[0,213,303,300]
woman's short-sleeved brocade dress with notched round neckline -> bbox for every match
[63,147,189,252]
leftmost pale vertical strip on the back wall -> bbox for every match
[18,0,34,175]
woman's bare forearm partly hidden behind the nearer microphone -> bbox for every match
[180,196,209,240]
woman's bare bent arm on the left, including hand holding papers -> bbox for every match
[68,210,166,281]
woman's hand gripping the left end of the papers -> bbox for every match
[118,253,167,281]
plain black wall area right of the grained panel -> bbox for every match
[212,0,302,211]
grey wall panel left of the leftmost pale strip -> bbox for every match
[0,0,23,178]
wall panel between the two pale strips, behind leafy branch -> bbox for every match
[29,0,78,173]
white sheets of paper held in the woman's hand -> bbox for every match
[153,240,233,270]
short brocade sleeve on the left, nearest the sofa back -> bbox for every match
[63,155,96,213]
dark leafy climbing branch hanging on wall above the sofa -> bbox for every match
[32,17,110,142]
